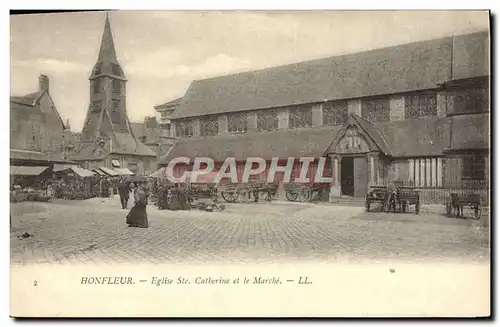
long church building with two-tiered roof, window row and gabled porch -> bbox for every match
[160,32,490,203]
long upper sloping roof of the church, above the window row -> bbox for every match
[170,32,489,119]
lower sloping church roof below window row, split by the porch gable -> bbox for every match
[160,115,458,165]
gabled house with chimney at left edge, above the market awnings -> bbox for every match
[10,75,77,165]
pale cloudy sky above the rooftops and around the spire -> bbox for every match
[10,11,489,132]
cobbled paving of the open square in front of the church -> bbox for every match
[11,197,489,264]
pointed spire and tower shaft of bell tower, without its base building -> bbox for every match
[82,14,132,141]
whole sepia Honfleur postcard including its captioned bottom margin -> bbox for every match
[10,10,491,317]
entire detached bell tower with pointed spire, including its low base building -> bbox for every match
[72,16,156,175]
